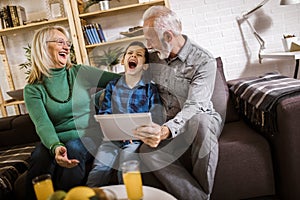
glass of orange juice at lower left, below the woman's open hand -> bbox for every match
[32,174,54,200]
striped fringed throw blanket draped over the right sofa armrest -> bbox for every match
[230,73,300,134]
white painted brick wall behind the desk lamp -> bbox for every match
[169,0,300,80]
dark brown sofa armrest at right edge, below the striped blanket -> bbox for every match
[272,95,300,199]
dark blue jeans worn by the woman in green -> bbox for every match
[26,139,93,200]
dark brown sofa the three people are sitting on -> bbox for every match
[0,59,300,200]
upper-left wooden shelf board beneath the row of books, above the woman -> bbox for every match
[0,17,68,36]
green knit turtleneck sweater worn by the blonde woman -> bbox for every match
[24,65,120,152]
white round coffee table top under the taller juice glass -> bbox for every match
[101,185,176,200]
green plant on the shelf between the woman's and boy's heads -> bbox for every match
[91,47,123,71]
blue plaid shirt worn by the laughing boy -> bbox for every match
[98,76,163,124]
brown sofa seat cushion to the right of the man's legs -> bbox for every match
[211,120,275,200]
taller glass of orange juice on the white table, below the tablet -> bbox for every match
[121,160,144,200]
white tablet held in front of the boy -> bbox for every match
[94,112,152,141]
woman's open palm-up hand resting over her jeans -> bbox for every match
[55,146,79,168]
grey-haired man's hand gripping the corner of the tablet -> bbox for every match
[133,123,171,147]
